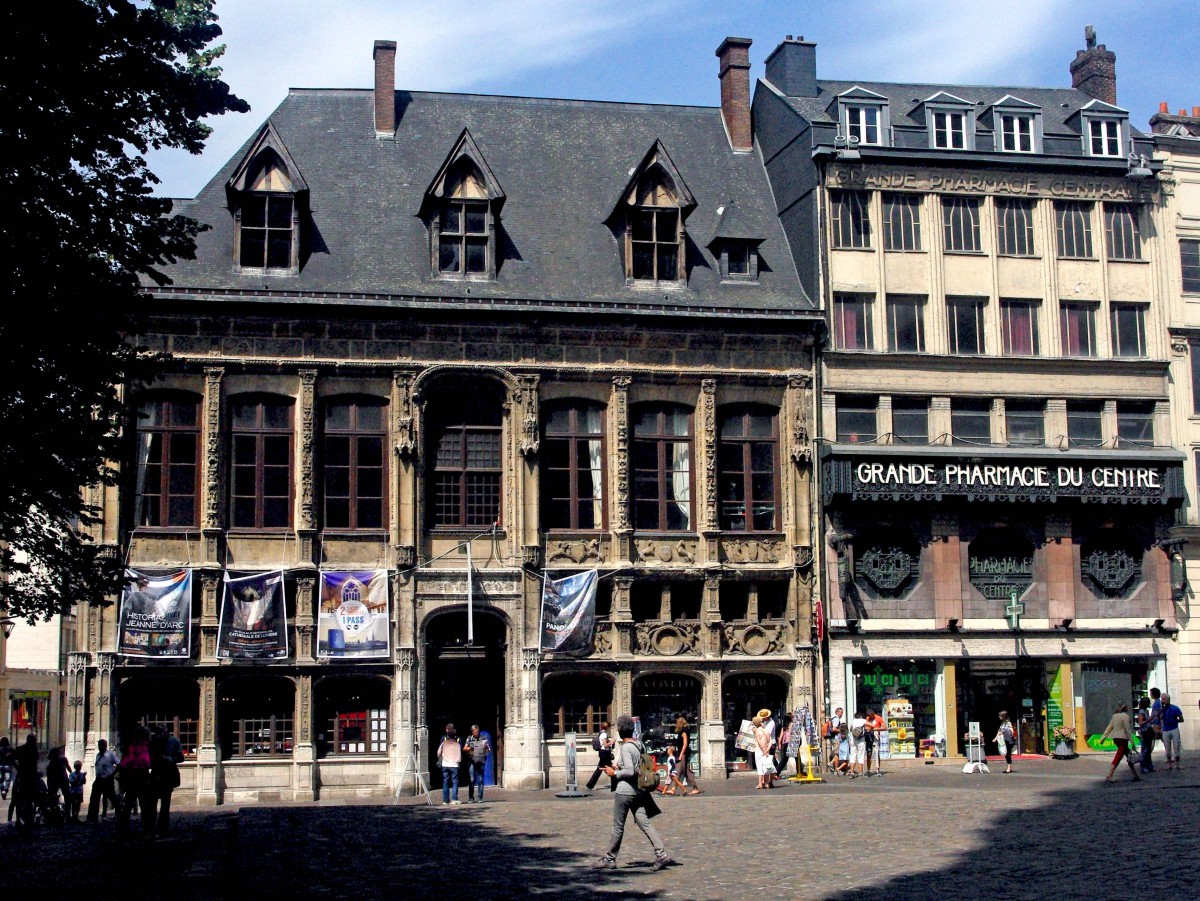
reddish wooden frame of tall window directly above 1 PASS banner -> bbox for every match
[322,396,388,531]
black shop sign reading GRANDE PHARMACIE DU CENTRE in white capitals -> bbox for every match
[822,445,1183,504]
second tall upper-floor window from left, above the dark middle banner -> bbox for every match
[229,396,293,529]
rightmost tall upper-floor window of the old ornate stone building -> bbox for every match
[716,408,779,531]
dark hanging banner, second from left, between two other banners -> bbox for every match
[217,571,288,660]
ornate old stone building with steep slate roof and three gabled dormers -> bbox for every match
[68,33,818,803]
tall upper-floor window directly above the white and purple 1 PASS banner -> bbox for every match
[323,398,388,529]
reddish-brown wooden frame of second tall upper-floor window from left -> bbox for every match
[229,395,295,531]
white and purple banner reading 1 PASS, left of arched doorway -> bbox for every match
[317,570,391,660]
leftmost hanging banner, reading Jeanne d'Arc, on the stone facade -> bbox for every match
[116,570,192,660]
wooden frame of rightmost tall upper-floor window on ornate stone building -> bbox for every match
[716,406,780,533]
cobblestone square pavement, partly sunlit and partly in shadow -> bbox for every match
[0,756,1200,901]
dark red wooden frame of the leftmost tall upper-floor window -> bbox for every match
[133,392,200,529]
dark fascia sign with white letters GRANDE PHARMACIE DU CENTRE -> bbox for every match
[823,455,1183,504]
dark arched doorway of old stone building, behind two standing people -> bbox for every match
[425,611,506,788]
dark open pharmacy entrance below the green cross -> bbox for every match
[955,660,1057,755]
